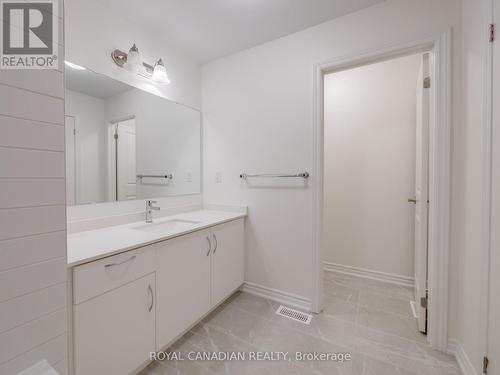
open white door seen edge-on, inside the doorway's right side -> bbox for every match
[415,53,430,332]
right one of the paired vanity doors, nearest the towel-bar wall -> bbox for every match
[211,219,244,306]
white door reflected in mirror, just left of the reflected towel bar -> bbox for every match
[116,119,137,201]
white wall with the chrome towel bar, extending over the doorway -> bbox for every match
[202,0,461,320]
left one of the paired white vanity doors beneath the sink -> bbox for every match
[156,230,210,350]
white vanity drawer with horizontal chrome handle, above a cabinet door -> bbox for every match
[73,246,155,305]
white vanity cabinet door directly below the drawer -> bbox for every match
[74,273,155,375]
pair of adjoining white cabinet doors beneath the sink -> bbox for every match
[156,219,244,350]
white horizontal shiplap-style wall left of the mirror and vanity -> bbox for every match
[0,0,68,375]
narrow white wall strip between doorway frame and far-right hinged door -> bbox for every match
[452,0,491,374]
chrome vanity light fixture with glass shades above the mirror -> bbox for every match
[111,44,170,85]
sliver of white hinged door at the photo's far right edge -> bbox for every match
[488,0,500,375]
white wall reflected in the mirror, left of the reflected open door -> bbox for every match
[66,90,106,204]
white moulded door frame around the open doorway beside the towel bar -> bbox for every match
[311,29,451,351]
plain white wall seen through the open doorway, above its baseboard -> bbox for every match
[323,55,422,278]
